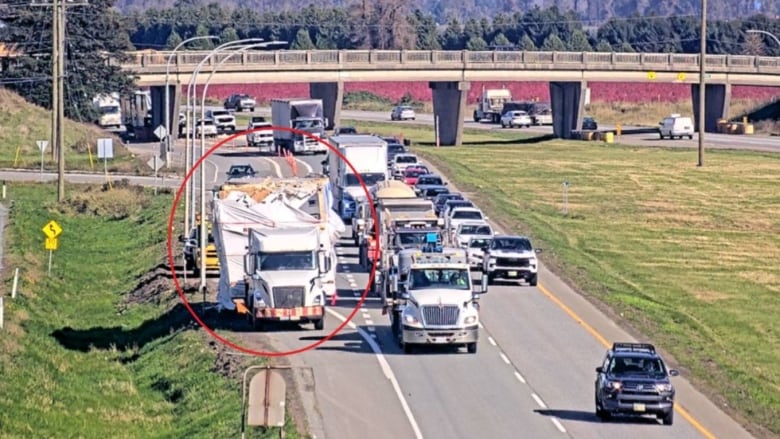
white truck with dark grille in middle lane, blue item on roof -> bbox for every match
[385,239,487,354]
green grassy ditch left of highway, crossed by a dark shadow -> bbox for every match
[0,183,299,439]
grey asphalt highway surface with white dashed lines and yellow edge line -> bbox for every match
[3,119,764,439]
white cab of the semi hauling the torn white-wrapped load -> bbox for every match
[244,225,333,330]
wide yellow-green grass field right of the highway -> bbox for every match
[348,119,780,437]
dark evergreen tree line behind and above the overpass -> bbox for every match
[0,0,780,120]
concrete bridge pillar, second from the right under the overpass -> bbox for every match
[550,81,588,139]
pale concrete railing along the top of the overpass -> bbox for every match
[120,50,780,74]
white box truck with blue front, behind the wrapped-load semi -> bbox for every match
[327,134,389,221]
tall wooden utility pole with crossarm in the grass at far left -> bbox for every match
[31,0,87,202]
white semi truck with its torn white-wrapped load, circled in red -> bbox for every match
[212,178,345,330]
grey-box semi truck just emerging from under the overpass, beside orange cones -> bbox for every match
[271,98,328,154]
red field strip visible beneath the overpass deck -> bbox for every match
[190,81,780,104]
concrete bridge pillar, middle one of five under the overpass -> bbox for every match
[428,81,471,146]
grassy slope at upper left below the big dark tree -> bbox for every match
[0,89,153,175]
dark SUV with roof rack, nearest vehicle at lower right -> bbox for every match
[596,343,679,425]
